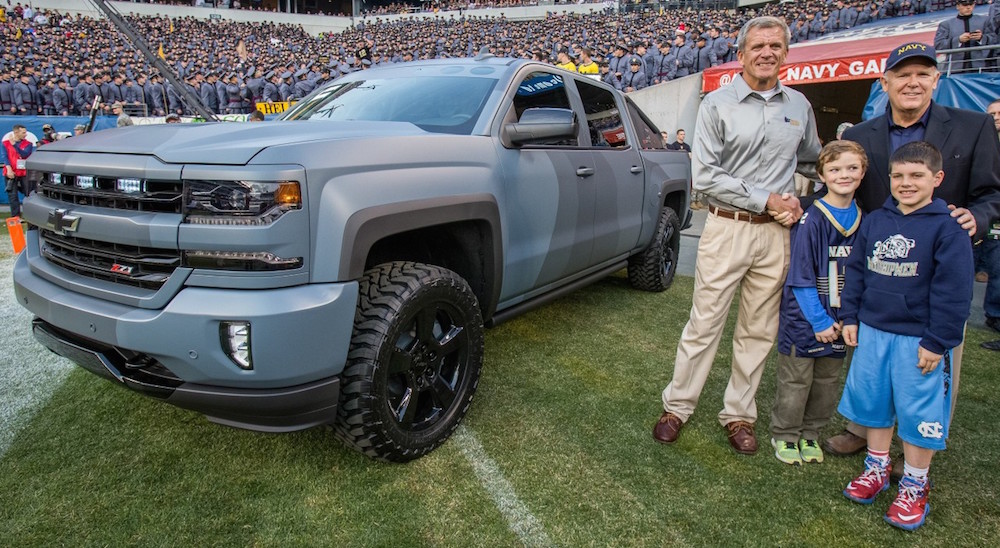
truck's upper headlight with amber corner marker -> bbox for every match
[184,180,302,226]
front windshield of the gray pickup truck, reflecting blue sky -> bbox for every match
[282,76,496,134]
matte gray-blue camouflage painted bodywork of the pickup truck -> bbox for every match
[14,59,690,430]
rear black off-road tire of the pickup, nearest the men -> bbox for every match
[628,207,681,291]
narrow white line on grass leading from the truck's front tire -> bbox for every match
[452,425,553,546]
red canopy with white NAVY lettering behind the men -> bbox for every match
[701,30,934,93]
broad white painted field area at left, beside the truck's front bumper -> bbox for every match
[0,253,73,457]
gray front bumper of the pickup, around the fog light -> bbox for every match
[14,240,358,431]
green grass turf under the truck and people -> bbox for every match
[0,275,1000,546]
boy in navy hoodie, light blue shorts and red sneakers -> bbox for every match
[838,141,973,531]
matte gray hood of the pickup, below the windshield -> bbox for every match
[44,120,426,165]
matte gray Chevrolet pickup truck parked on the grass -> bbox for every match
[14,56,690,461]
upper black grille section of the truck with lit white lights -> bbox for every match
[38,173,184,213]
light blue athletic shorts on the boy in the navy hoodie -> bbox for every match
[837,323,951,450]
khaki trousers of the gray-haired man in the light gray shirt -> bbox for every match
[663,214,789,425]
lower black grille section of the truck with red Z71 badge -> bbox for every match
[39,229,181,290]
